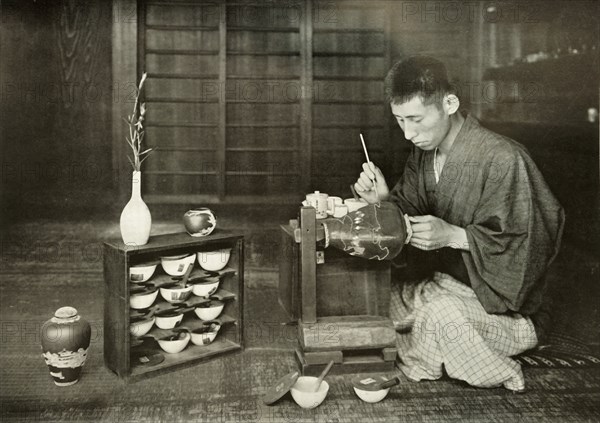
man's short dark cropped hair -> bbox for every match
[384,56,453,104]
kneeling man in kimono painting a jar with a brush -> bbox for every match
[354,57,564,391]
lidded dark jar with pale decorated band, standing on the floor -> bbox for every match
[42,307,91,386]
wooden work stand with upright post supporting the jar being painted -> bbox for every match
[279,207,397,375]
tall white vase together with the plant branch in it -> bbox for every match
[120,73,155,246]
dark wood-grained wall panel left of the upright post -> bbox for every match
[0,0,113,225]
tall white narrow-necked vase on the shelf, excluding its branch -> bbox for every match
[121,171,152,245]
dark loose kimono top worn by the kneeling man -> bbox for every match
[390,116,564,336]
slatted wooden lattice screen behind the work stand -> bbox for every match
[138,0,389,202]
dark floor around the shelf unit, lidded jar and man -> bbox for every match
[0,218,600,423]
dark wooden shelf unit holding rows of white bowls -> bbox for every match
[103,230,244,381]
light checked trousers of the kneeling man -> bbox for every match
[390,272,537,391]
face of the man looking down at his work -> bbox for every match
[391,96,450,151]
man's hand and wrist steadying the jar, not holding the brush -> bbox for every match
[408,215,469,251]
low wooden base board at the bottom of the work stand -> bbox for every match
[295,348,396,376]
